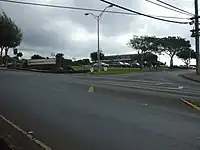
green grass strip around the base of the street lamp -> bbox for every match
[89,67,149,75]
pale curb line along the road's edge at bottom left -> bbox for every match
[0,115,51,150]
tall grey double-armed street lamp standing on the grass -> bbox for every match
[85,5,113,72]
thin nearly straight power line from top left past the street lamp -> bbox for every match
[0,0,190,19]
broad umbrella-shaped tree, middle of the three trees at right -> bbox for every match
[155,36,191,68]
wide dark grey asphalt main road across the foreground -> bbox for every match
[0,71,200,150]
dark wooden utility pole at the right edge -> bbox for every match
[194,0,200,75]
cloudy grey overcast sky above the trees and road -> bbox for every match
[0,0,197,64]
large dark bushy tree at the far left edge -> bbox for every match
[0,11,22,66]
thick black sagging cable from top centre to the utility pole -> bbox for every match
[100,0,189,24]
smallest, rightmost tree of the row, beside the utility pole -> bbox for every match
[176,48,196,67]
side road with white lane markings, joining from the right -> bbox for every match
[65,70,200,101]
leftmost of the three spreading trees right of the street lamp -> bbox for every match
[128,36,157,68]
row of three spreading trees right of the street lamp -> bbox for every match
[127,36,196,68]
